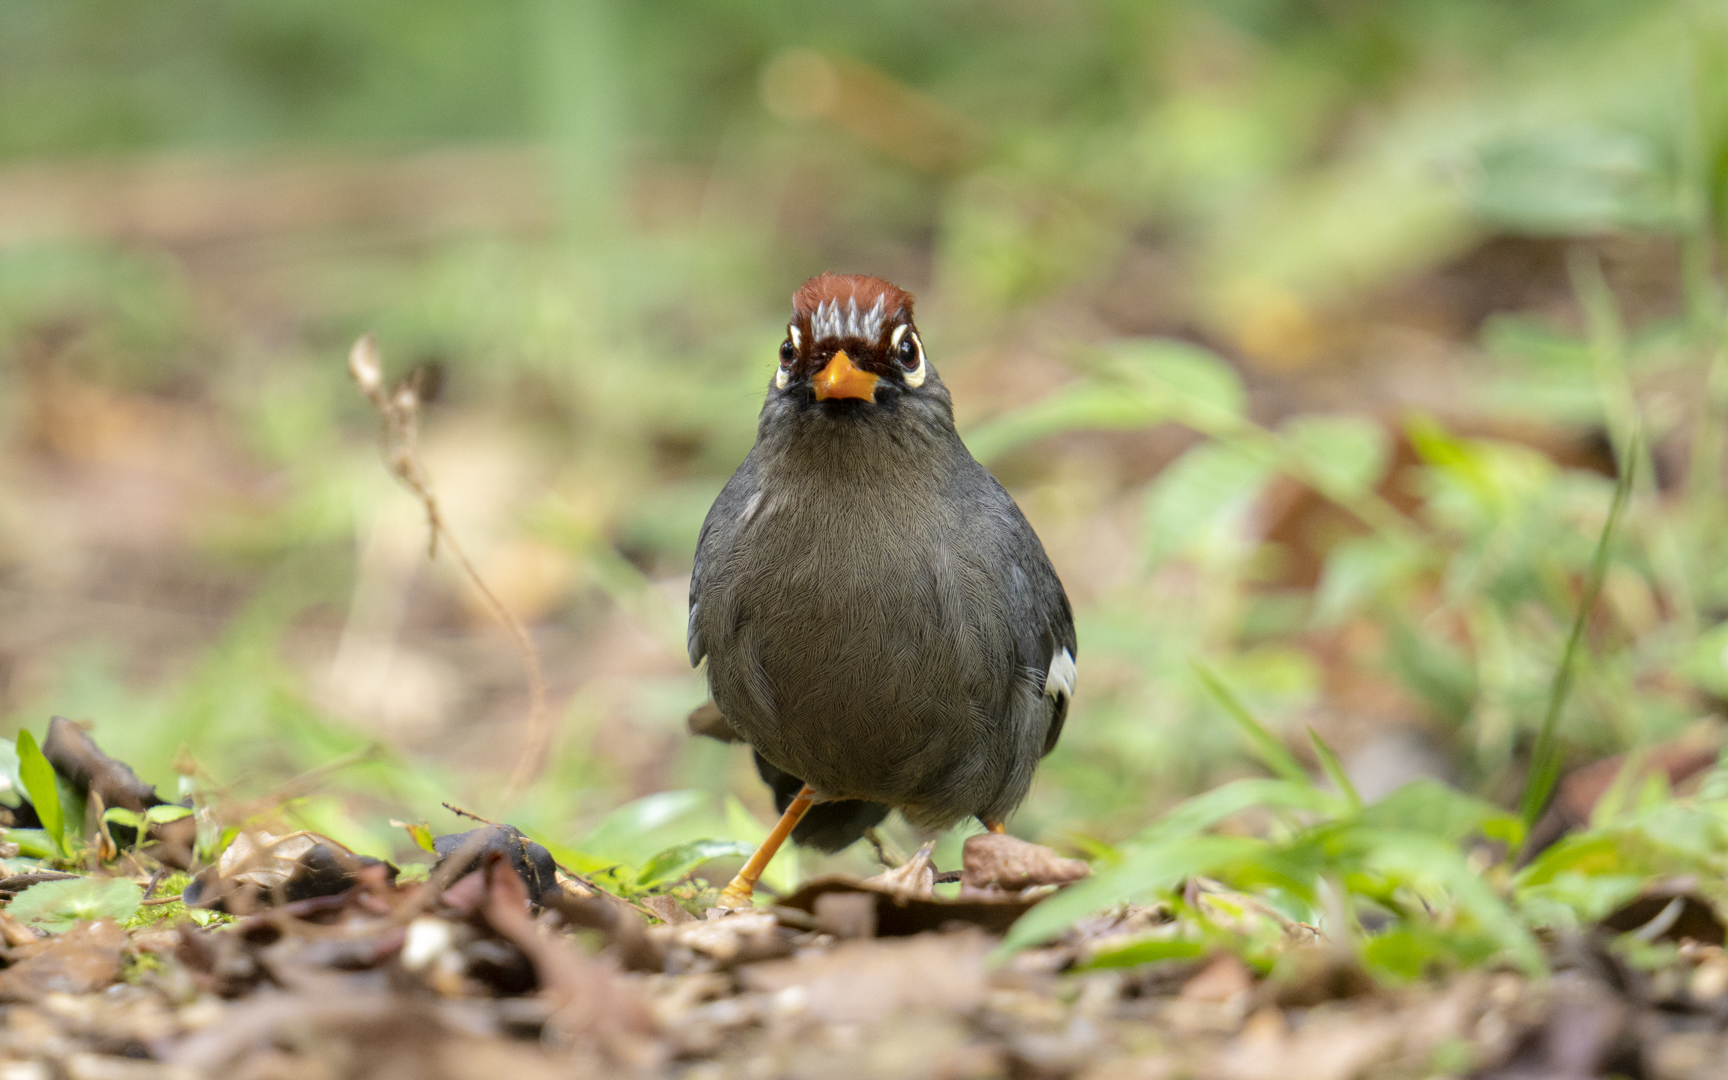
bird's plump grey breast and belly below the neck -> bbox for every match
[691,439,1061,826]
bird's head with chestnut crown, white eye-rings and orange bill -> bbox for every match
[772,273,947,415]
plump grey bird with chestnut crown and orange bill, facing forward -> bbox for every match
[688,273,1078,907]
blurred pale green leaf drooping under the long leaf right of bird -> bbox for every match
[1142,442,1274,565]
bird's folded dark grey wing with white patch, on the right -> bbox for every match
[980,467,1080,753]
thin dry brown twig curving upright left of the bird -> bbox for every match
[347,334,553,802]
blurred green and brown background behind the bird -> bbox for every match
[0,0,1728,891]
